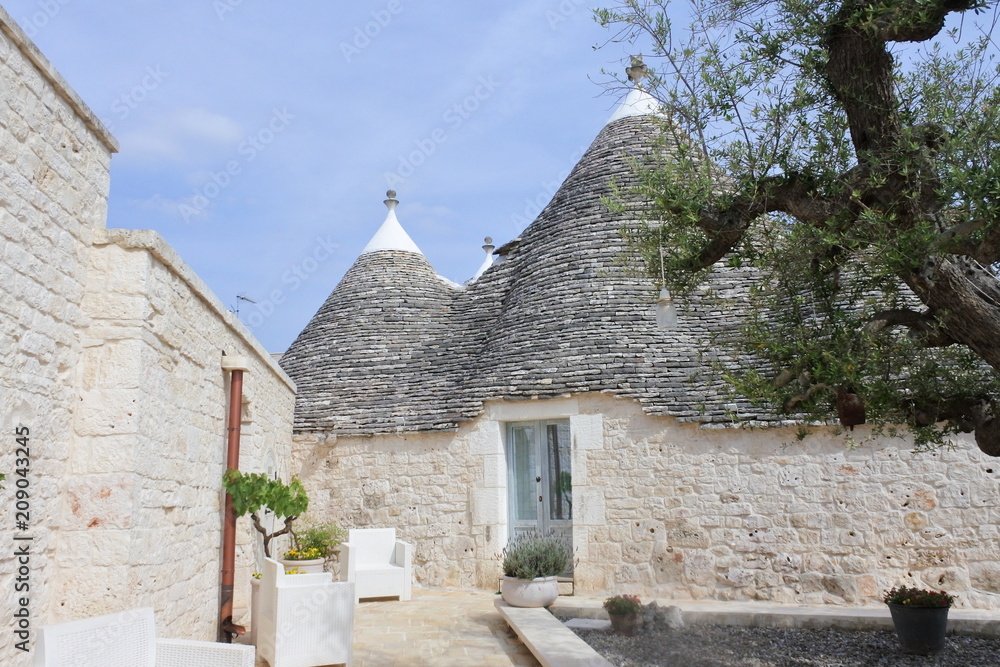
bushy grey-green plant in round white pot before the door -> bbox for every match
[500,533,571,607]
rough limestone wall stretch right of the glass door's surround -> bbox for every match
[582,400,1000,609]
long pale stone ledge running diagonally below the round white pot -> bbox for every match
[493,598,613,667]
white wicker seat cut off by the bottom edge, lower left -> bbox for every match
[35,607,254,667]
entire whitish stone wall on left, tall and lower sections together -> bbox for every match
[0,13,294,665]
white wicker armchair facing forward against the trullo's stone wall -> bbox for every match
[340,528,413,600]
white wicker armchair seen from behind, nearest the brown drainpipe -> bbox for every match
[252,558,354,667]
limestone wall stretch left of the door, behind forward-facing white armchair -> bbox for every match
[292,429,488,587]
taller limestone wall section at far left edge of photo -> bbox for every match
[0,8,116,665]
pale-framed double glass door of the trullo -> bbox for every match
[507,419,573,564]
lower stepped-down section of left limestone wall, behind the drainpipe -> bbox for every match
[58,230,294,639]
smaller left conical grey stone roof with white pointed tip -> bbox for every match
[281,196,460,433]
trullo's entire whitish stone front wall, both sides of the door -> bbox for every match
[294,395,1000,609]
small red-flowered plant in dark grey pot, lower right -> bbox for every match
[882,586,955,655]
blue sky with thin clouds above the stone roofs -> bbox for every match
[0,0,628,352]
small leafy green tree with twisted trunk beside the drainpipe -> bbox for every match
[222,470,309,558]
